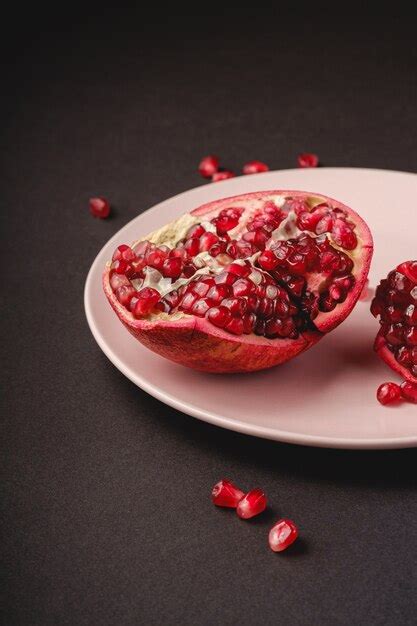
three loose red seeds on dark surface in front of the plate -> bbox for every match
[211,480,298,552]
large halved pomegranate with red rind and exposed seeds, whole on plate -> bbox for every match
[103,191,373,372]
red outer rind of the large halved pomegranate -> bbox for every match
[103,190,373,373]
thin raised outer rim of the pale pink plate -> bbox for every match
[83,167,417,450]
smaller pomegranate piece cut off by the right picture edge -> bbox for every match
[371,261,417,383]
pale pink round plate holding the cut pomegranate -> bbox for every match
[85,168,417,448]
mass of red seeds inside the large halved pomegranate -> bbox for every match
[110,201,356,339]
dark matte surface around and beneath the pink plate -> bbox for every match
[0,7,417,625]
